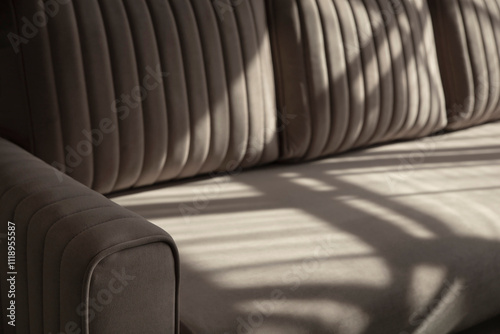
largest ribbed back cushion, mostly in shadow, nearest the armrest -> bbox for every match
[1,0,278,193]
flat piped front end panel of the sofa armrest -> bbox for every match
[89,243,176,334]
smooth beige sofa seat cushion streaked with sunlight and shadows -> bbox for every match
[113,123,500,334]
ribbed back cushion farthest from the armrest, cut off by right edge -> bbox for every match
[429,0,500,130]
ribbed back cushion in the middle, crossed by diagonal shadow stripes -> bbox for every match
[268,0,446,160]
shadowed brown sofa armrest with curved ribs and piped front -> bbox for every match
[0,138,179,334]
